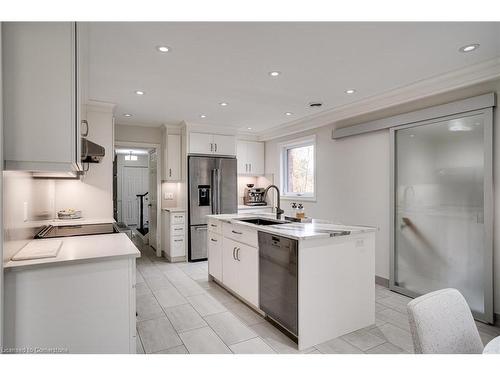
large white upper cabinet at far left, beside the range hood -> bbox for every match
[2,22,85,176]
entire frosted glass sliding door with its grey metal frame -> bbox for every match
[391,109,493,322]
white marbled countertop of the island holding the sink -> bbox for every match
[207,213,376,240]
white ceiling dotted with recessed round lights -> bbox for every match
[89,22,500,132]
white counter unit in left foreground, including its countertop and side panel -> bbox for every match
[3,229,140,353]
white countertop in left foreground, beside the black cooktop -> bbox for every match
[4,234,141,270]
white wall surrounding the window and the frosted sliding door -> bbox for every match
[266,81,500,313]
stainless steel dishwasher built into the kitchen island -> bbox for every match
[258,232,299,337]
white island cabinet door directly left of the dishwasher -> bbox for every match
[235,244,259,307]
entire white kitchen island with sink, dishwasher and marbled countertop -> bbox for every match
[207,214,375,350]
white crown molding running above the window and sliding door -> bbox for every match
[257,57,500,141]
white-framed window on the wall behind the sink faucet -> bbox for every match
[281,138,316,199]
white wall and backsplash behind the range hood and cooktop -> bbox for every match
[55,102,113,218]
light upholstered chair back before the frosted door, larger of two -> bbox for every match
[408,289,484,354]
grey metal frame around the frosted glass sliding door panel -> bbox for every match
[389,107,494,323]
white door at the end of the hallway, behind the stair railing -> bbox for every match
[122,167,145,225]
